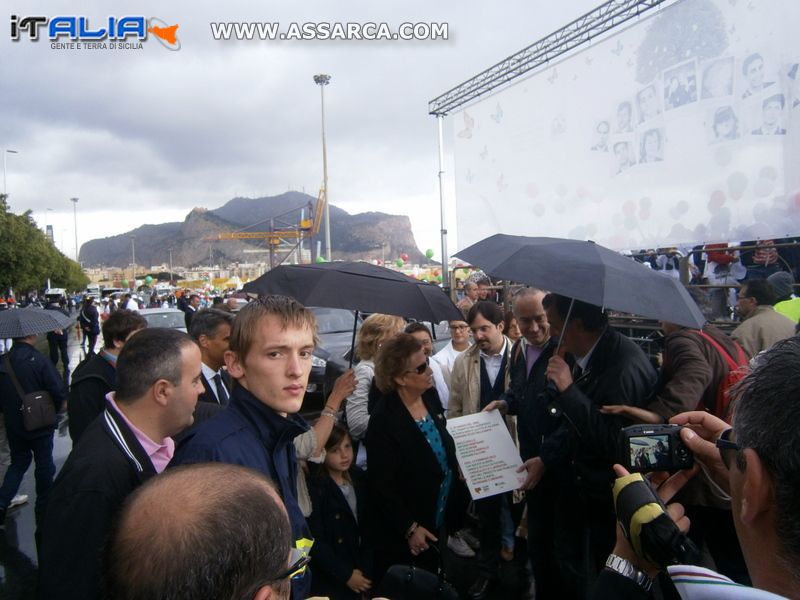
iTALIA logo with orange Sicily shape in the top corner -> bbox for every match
[11,15,181,50]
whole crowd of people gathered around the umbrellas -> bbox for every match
[0,268,800,600]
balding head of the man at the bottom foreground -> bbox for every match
[105,463,291,600]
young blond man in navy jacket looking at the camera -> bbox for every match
[175,296,317,599]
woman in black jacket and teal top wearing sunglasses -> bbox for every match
[366,333,466,582]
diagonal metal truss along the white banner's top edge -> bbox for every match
[428,0,671,116]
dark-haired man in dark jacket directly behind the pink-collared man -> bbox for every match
[67,310,147,444]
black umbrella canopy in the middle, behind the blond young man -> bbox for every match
[242,262,464,323]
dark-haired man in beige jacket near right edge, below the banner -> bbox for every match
[731,279,795,358]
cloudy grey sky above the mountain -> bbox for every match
[0,0,600,257]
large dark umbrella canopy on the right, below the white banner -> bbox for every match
[456,234,705,327]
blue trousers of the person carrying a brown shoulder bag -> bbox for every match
[0,431,56,521]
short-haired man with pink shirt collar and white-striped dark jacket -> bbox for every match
[39,328,203,600]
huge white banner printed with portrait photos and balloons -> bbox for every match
[453,0,800,249]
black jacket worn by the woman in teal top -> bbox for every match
[366,392,466,560]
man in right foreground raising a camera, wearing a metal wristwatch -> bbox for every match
[595,336,800,599]
